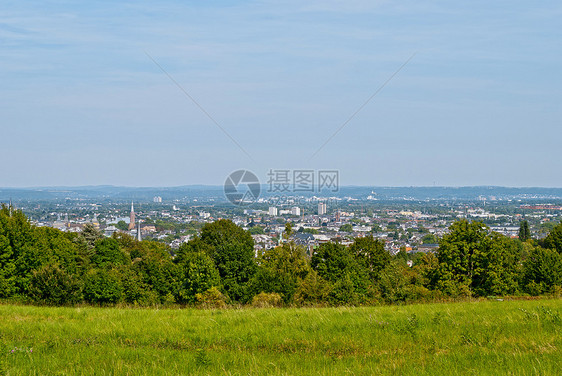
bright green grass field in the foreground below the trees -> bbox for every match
[0,299,562,375]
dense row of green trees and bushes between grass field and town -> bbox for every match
[0,206,562,307]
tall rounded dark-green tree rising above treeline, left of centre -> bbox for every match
[201,219,256,301]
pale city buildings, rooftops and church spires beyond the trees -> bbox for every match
[14,196,562,253]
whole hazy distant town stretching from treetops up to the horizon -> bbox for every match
[0,188,562,254]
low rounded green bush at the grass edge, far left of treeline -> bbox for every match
[29,264,81,305]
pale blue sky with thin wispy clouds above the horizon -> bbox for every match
[0,0,562,187]
